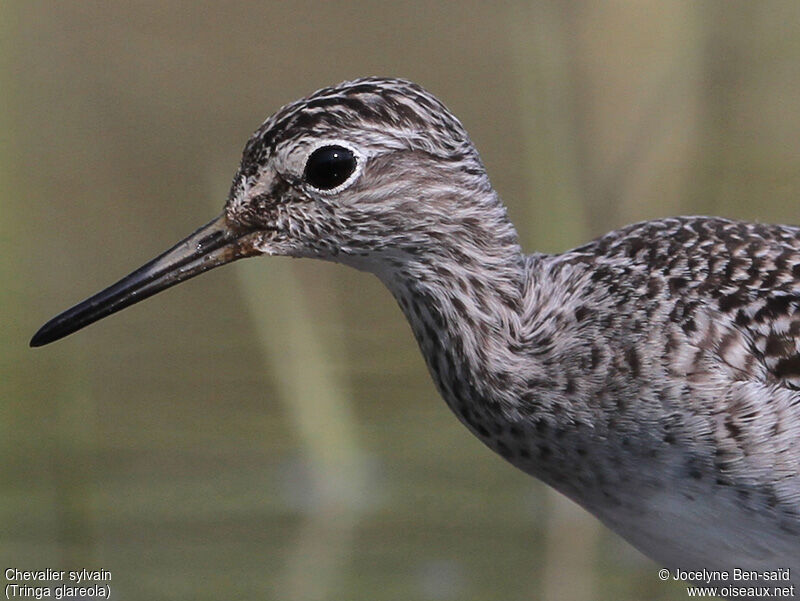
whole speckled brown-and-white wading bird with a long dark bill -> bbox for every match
[31,77,800,584]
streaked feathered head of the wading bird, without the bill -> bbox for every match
[225,78,491,269]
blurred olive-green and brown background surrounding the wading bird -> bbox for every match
[0,0,800,601]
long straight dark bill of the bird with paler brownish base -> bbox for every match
[31,215,260,346]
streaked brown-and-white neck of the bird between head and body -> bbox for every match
[377,206,526,438]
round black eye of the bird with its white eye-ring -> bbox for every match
[303,140,363,194]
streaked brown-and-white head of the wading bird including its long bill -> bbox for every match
[31,78,513,346]
